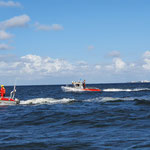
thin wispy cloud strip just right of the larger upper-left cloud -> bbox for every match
[35,22,64,31]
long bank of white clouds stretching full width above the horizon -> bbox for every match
[0,51,150,84]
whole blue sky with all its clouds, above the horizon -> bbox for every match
[0,0,150,85]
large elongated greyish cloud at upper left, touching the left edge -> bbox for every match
[0,15,30,29]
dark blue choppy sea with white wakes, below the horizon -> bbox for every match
[0,83,150,150]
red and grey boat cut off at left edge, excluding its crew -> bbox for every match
[0,86,20,105]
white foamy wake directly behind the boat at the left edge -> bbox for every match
[20,98,75,105]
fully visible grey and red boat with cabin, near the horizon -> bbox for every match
[61,81,101,92]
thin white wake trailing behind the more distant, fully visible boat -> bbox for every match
[103,88,150,92]
